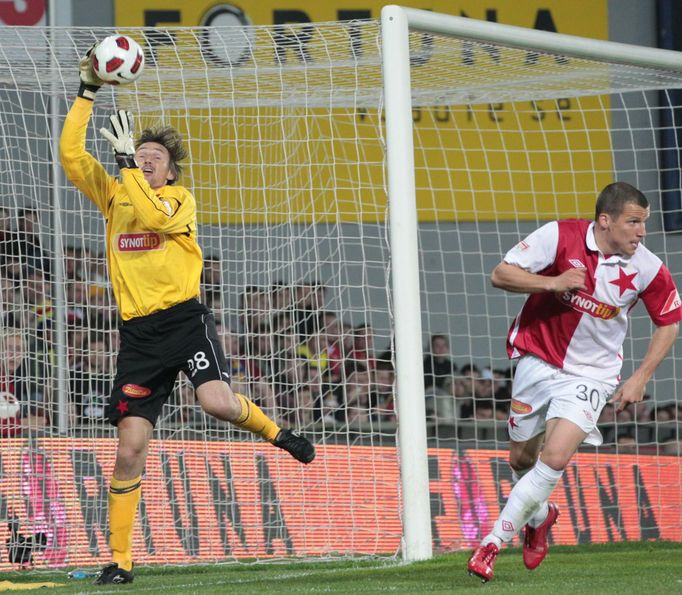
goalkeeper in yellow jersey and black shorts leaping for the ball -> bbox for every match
[59,50,315,584]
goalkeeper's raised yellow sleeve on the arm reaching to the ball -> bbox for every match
[59,97,118,217]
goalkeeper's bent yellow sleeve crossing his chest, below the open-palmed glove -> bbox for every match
[121,168,196,234]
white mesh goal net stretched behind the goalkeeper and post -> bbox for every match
[0,8,682,568]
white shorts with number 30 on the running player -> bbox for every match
[508,355,616,446]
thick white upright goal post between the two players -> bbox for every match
[381,7,432,560]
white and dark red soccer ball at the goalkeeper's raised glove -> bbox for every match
[92,35,144,85]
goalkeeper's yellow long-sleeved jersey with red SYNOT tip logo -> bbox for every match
[59,97,203,320]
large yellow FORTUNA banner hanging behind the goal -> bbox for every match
[115,0,613,224]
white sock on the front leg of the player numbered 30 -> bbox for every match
[481,460,564,547]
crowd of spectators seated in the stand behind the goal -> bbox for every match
[0,207,682,454]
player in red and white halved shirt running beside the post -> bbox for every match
[468,182,682,581]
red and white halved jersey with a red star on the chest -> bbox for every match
[504,219,682,385]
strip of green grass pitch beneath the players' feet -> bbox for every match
[2,542,682,595]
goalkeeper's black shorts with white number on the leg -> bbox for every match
[107,300,230,425]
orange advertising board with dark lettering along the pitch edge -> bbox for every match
[0,438,682,570]
